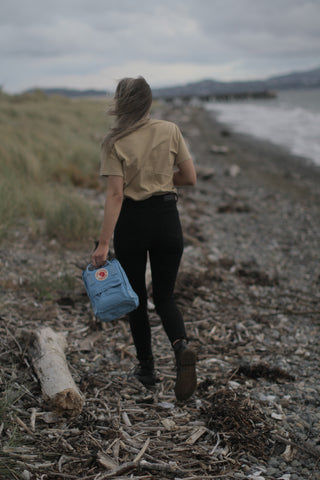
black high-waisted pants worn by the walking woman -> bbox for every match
[114,194,186,361]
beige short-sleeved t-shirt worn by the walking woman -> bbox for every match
[100,120,191,200]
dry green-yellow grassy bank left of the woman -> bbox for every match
[0,92,110,241]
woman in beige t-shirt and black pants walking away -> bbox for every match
[92,77,197,400]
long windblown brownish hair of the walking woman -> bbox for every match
[102,77,152,153]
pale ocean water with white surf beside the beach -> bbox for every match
[206,88,320,165]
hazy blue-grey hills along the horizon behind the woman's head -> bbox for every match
[29,68,320,98]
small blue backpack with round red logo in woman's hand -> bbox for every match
[82,258,139,322]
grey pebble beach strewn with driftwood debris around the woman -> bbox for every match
[0,105,320,480]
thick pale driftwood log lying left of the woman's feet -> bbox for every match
[30,327,84,417]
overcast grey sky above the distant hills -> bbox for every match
[0,0,320,93]
